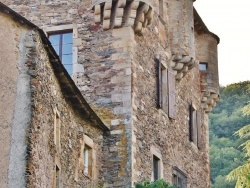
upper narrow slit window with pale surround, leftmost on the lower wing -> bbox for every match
[54,111,61,153]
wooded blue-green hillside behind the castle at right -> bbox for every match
[209,81,250,188]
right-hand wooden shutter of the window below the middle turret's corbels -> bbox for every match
[168,69,175,119]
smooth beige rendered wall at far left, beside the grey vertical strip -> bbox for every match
[0,14,21,187]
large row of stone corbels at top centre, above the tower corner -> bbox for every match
[93,0,154,33]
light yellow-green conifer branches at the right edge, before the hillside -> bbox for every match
[227,104,250,188]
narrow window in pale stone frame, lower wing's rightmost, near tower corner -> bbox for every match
[83,144,92,177]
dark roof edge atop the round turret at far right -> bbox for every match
[194,8,220,44]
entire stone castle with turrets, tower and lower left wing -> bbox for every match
[0,0,219,188]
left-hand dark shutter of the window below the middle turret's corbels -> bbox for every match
[156,59,162,108]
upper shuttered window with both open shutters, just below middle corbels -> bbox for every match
[157,60,175,119]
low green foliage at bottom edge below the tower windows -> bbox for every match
[135,179,176,188]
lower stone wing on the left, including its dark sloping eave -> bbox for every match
[0,4,108,187]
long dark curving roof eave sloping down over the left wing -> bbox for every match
[0,2,109,131]
